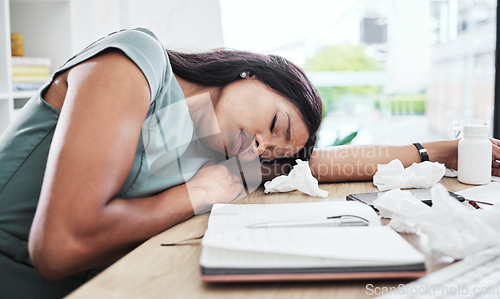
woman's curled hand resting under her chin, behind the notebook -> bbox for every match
[186,163,243,214]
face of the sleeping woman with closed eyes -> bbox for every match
[206,77,309,161]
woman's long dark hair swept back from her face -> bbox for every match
[167,49,322,164]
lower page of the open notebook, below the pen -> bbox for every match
[202,226,424,263]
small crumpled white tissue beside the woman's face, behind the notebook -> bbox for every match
[264,159,328,198]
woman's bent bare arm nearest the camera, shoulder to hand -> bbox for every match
[28,51,241,279]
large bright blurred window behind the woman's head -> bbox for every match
[220,0,497,147]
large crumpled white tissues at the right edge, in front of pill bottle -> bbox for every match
[374,184,500,259]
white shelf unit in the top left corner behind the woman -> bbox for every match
[0,0,74,135]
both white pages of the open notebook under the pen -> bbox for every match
[202,201,423,262]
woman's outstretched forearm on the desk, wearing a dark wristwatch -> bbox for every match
[309,140,458,182]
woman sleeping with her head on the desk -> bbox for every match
[0,29,500,298]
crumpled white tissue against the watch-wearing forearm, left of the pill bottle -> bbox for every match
[373,159,446,191]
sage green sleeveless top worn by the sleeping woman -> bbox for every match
[0,29,211,298]
